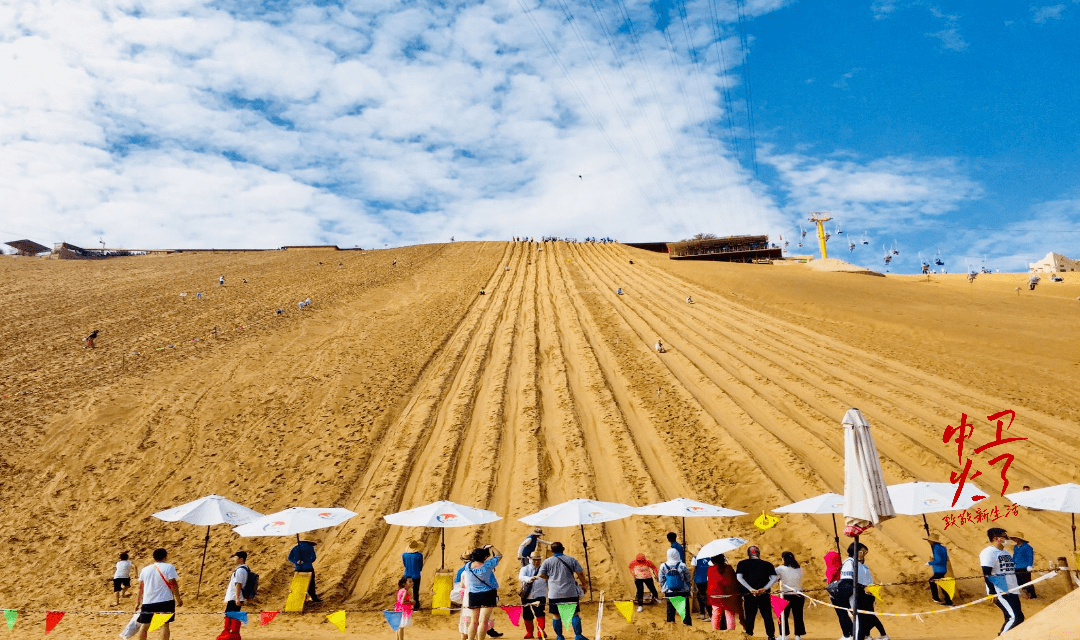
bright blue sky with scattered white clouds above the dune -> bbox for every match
[0,0,1080,272]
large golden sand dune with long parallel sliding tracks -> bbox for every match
[0,243,1080,638]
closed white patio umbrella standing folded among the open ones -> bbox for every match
[843,408,896,638]
